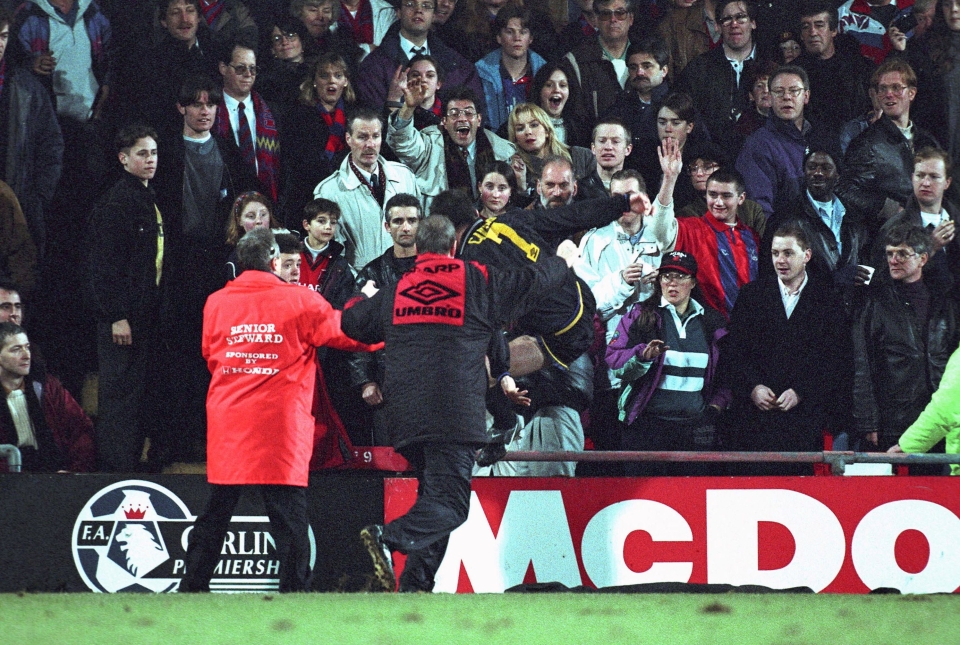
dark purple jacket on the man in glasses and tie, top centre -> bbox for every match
[357,30,486,114]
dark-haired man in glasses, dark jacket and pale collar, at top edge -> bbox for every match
[676,0,757,157]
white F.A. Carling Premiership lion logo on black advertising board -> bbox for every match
[71,480,317,593]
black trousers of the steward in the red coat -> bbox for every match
[180,484,313,592]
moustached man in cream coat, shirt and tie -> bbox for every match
[313,108,420,273]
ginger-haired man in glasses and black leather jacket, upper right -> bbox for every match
[837,59,939,232]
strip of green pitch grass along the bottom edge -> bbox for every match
[0,593,960,645]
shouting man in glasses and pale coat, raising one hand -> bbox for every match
[386,85,517,211]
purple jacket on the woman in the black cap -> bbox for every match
[606,303,732,425]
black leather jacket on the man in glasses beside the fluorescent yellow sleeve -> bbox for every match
[853,277,960,448]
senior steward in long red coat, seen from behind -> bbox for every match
[180,229,380,591]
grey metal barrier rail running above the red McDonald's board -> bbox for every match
[501,450,960,475]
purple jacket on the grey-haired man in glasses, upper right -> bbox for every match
[737,115,811,219]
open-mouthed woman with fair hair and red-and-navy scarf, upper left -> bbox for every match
[279,53,356,231]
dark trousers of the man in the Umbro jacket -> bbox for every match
[383,443,477,591]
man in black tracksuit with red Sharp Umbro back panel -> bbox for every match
[341,215,570,591]
